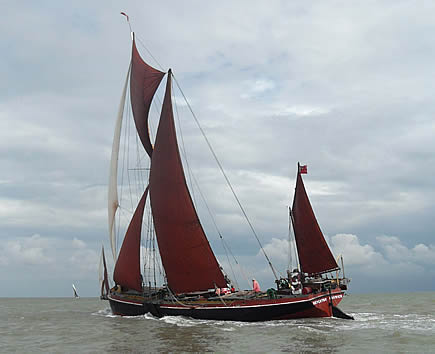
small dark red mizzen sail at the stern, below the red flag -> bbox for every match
[292,170,338,274]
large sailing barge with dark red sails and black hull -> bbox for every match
[101,28,349,321]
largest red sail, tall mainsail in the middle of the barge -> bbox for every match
[149,71,226,294]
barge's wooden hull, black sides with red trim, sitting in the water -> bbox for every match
[109,289,344,322]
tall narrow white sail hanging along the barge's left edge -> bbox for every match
[108,64,131,261]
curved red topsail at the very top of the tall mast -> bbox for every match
[130,37,165,157]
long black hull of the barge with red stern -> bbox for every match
[109,294,342,322]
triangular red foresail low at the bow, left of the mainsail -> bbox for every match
[113,187,148,292]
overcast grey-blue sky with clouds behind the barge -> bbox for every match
[0,0,435,297]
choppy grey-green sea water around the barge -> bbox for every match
[0,292,435,353]
